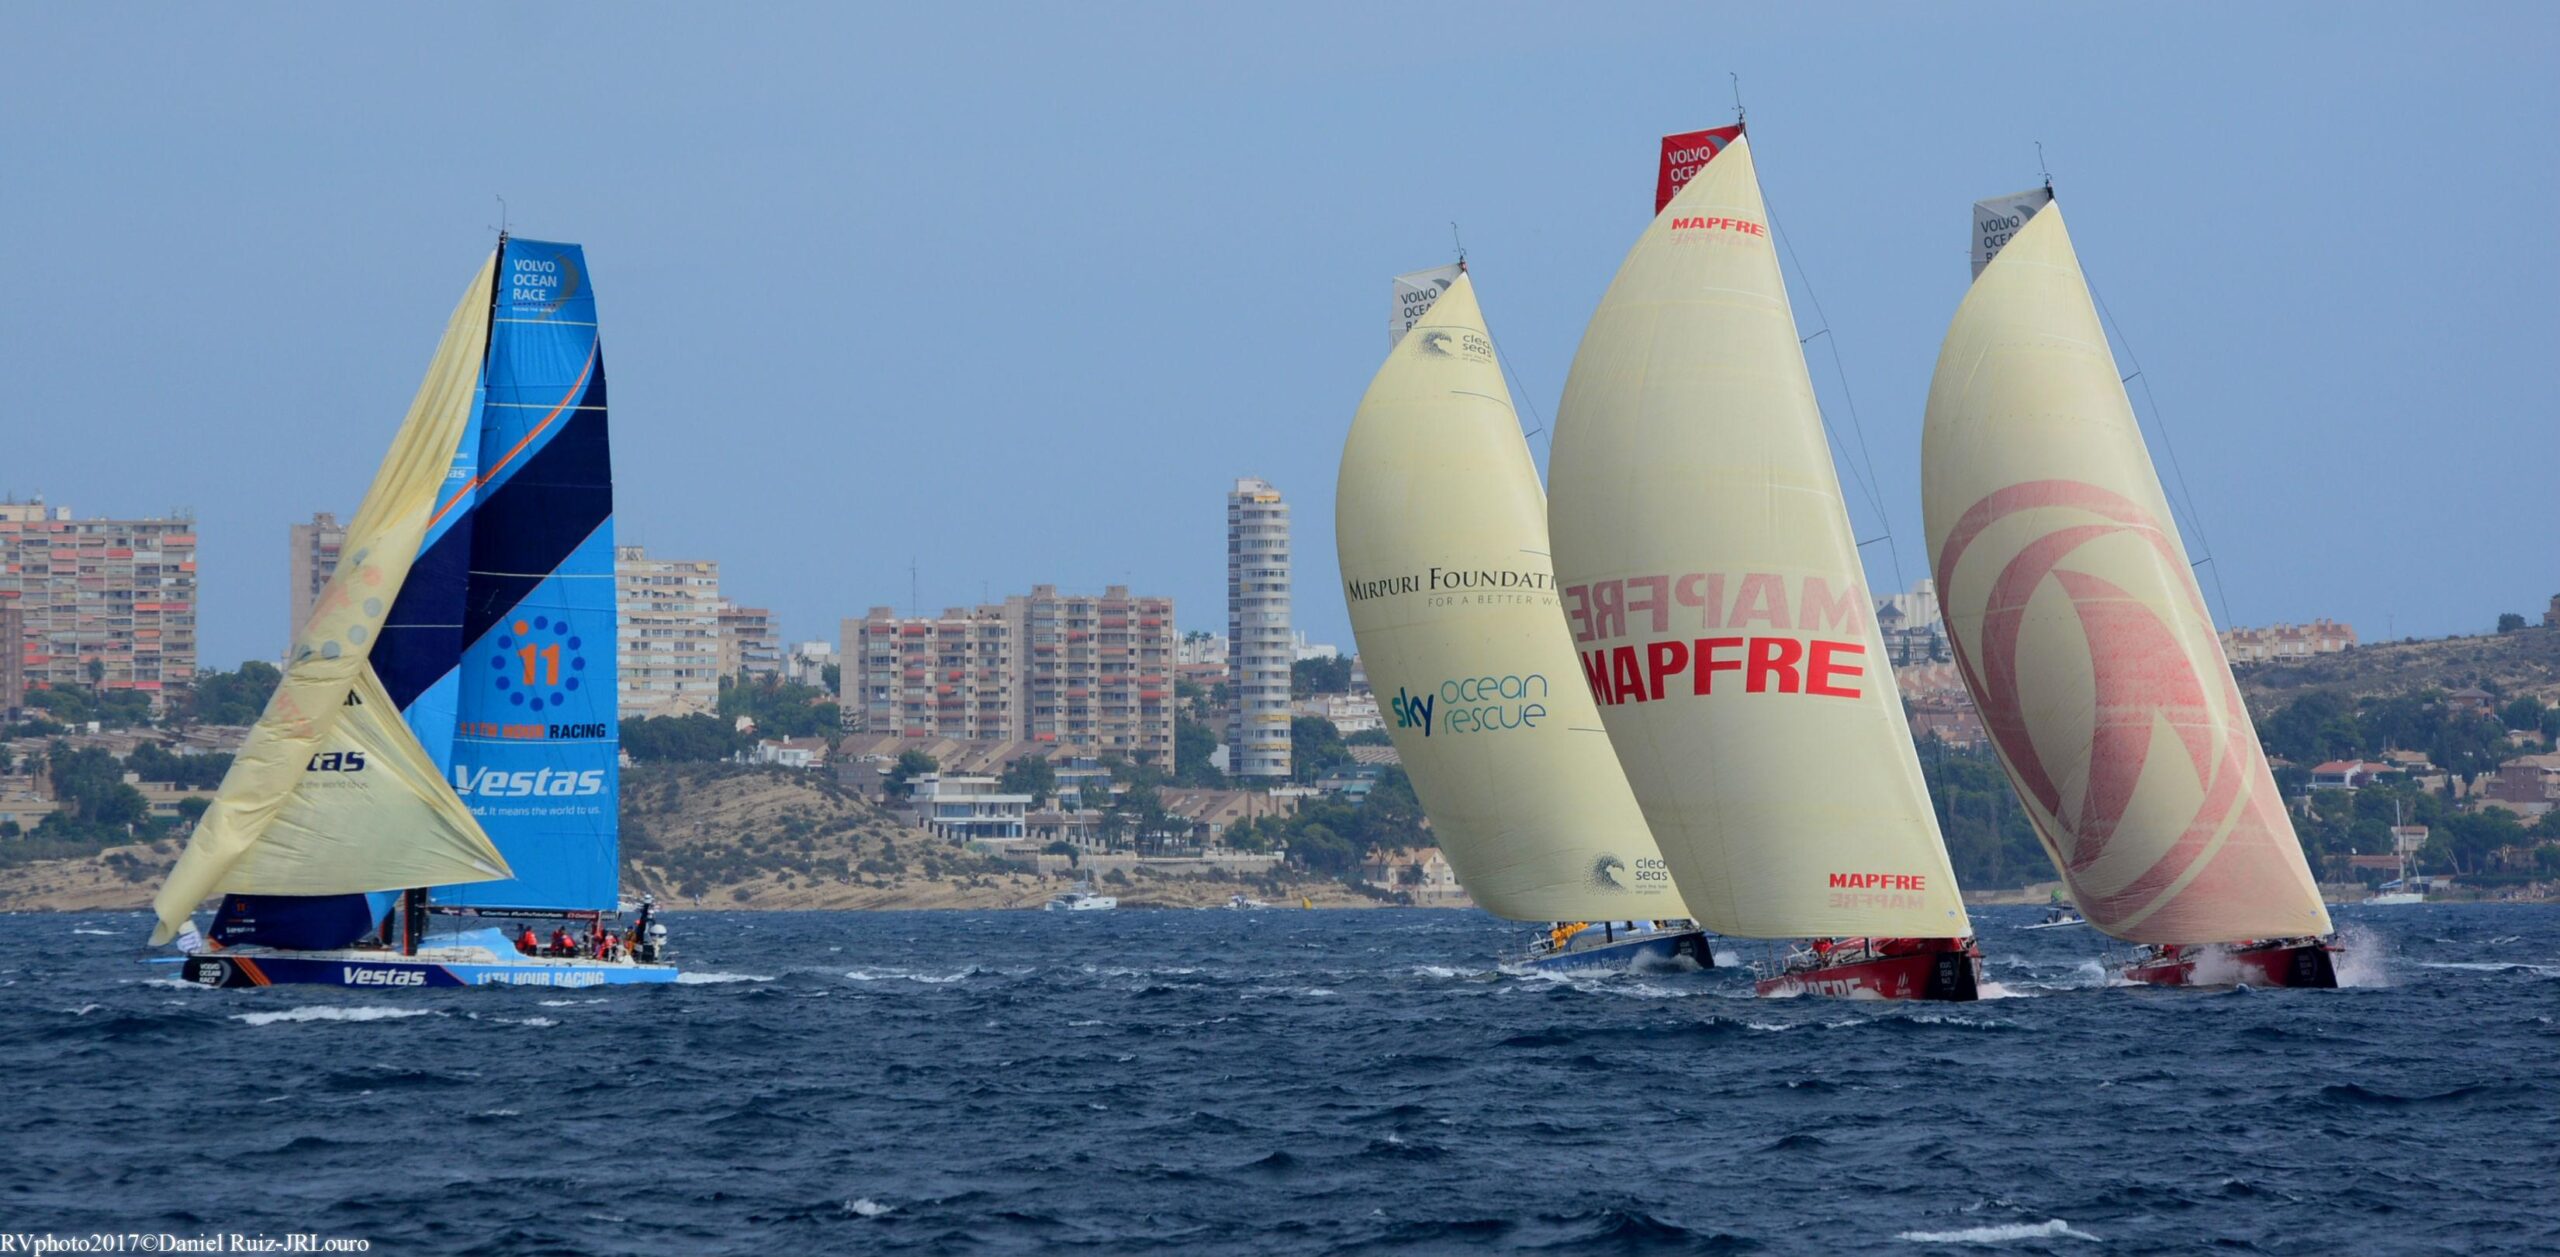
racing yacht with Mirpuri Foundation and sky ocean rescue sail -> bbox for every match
[1334,266,1715,968]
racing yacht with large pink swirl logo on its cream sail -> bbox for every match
[1923,195,2337,986]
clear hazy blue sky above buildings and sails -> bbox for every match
[0,5,2560,666]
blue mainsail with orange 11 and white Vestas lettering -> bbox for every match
[432,241,622,911]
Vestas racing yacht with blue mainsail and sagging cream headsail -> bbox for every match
[156,238,676,986]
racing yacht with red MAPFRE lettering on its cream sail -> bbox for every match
[1549,133,1979,998]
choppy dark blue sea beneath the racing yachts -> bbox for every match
[0,906,2560,1257]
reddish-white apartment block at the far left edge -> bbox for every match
[0,499,197,701]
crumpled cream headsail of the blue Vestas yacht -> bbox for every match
[151,259,507,945]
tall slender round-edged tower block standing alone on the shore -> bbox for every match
[1226,476,1295,778]
